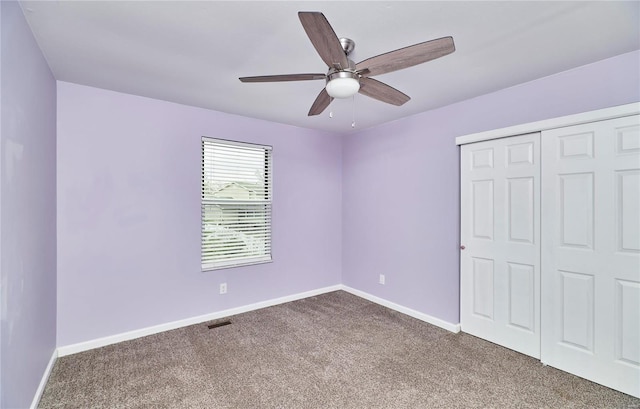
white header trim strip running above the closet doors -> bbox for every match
[456,102,640,145]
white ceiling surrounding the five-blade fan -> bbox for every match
[21,1,640,132]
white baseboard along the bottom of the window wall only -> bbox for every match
[58,285,342,357]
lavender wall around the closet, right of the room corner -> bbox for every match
[342,51,640,323]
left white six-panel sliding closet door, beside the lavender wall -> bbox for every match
[460,133,540,358]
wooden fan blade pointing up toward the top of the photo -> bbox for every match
[298,11,349,68]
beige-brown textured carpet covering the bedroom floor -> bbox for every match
[40,291,640,409]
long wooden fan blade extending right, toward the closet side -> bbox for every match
[356,37,456,77]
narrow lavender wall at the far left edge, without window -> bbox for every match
[0,1,56,408]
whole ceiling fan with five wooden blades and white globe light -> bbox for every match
[240,11,455,116]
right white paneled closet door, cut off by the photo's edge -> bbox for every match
[542,116,640,396]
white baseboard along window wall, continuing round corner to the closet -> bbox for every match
[57,284,460,357]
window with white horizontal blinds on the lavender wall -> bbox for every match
[201,137,271,270]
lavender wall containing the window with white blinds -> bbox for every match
[57,82,342,346]
